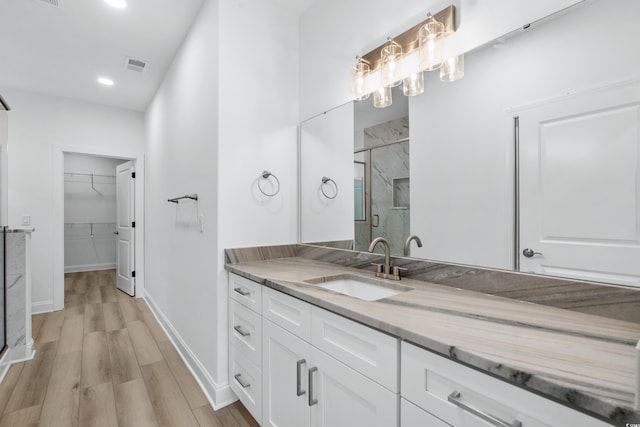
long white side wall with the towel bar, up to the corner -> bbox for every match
[145,1,220,404]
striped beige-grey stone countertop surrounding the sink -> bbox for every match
[225,245,640,425]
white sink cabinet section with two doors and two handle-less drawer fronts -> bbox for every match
[262,288,399,427]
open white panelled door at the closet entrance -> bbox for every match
[116,161,135,296]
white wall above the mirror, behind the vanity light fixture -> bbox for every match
[300,0,578,121]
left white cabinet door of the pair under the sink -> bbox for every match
[262,319,311,427]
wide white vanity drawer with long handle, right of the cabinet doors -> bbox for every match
[401,342,607,427]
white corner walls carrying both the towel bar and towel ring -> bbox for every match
[146,0,298,406]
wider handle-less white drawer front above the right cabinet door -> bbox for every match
[311,306,399,393]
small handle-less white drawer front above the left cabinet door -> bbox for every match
[262,286,311,342]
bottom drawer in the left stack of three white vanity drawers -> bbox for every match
[229,345,262,424]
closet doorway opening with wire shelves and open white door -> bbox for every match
[64,153,135,296]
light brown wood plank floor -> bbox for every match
[0,270,258,427]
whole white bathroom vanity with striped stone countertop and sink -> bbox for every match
[226,245,640,427]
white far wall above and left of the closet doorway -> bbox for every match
[1,88,144,311]
